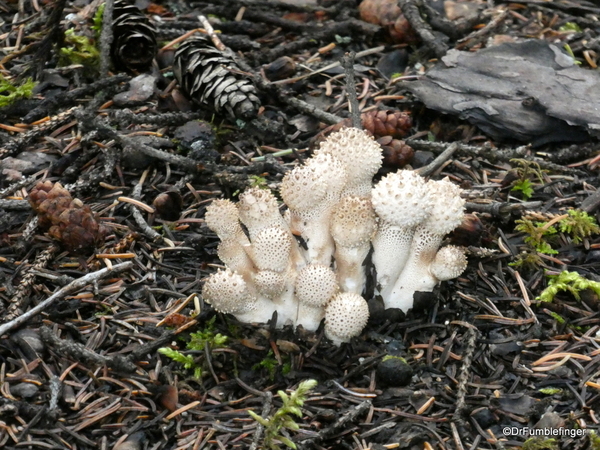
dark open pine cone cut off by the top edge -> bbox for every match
[111,0,158,72]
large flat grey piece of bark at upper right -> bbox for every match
[404,40,600,146]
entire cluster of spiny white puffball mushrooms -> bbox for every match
[202,128,467,345]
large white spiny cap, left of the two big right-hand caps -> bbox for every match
[371,170,433,228]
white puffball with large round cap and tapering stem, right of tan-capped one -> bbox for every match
[371,170,433,299]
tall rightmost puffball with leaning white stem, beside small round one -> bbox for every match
[383,178,465,312]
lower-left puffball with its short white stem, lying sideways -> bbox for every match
[202,269,275,323]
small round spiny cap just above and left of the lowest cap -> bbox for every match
[295,264,338,308]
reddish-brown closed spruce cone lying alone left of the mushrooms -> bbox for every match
[29,180,105,254]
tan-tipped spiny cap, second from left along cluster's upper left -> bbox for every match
[238,188,283,239]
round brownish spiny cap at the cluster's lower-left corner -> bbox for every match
[202,269,256,314]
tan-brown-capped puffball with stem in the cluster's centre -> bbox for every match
[331,196,377,294]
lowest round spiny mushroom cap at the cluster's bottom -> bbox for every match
[325,292,369,345]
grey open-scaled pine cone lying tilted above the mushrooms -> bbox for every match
[173,36,260,120]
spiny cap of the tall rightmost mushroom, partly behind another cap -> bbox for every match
[423,178,465,235]
